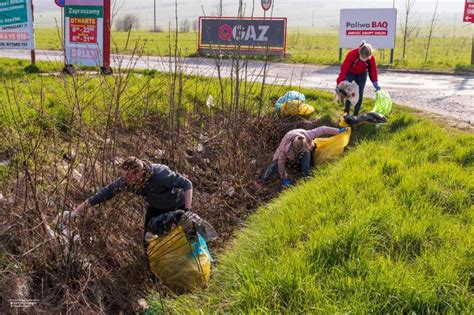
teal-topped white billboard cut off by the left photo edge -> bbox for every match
[0,0,35,50]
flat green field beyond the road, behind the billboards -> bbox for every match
[35,28,473,71]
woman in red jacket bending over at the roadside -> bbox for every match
[337,41,380,116]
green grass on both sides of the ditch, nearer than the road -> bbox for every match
[0,60,474,314]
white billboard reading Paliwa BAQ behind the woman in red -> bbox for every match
[339,9,397,49]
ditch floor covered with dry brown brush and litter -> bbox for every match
[0,113,340,313]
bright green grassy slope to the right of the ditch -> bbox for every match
[153,112,474,314]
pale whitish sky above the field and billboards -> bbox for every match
[33,0,465,29]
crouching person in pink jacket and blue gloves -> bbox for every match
[257,126,346,188]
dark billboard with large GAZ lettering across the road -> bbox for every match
[198,17,287,55]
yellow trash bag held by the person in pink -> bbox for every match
[314,128,351,164]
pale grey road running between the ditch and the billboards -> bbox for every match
[0,50,474,128]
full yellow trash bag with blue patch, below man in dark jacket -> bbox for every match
[147,226,212,293]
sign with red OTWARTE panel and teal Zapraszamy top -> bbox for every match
[64,0,110,67]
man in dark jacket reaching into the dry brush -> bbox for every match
[57,156,193,236]
